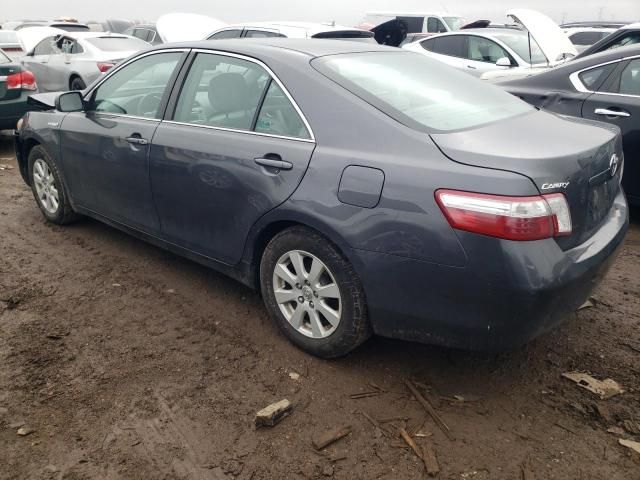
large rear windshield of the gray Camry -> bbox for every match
[312,52,533,132]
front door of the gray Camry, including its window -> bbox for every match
[60,50,186,233]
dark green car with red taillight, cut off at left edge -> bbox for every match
[0,50,38,130]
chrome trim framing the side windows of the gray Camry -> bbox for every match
[83,48,316,143]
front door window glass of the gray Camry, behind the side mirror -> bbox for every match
[91,52,182,119]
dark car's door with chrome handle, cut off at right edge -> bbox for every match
[582,58,640,205]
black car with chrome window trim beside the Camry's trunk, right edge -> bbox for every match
[500,45,640,205]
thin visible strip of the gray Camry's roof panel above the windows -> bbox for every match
[154,37,400,58]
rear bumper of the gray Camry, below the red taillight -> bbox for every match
[351,192,629,350]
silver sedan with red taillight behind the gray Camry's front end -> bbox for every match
[21,32,149,92]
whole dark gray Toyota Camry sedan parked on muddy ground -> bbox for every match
[16,39,628,357]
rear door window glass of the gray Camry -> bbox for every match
[173,53,310,139]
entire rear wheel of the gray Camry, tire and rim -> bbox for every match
[260,227,371,358]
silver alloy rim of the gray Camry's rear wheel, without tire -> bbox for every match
[273,250,342,338]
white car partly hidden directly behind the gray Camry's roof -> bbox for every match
[205,22,376,43]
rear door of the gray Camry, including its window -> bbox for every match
[151,52,315,264]
